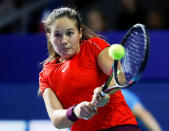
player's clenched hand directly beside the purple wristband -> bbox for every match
[74,102,97,120]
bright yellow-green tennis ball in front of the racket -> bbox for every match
[108,44,125,60]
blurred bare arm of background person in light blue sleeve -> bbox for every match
[133,103,162,131]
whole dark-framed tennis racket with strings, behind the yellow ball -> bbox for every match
[101,24,149,96]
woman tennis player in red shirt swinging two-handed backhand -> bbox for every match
[39,7,140,131]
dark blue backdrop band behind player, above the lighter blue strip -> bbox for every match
[0,31,169,81]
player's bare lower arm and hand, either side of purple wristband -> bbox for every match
[43,88,96,129]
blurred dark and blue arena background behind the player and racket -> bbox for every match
[0,0,169,131]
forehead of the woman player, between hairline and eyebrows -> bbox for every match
[51,17,77,30]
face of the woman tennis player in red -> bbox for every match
[48,17,82,59]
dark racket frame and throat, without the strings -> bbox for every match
[101,24,150,96]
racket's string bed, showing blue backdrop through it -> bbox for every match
[121,29,146,82]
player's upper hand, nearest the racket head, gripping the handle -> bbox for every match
[91,87,110,107]
